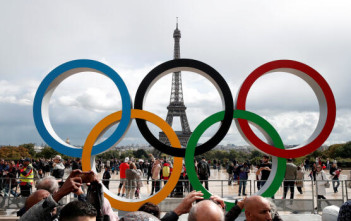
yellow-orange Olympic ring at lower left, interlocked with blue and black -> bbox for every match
[82,109,183,211]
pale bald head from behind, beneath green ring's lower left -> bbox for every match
[188,200,224,221]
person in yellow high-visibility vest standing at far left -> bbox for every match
[19,158,34,197]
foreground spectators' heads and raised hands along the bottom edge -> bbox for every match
[8,169,351,221]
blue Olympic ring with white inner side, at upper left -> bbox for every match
[33,59,132,157]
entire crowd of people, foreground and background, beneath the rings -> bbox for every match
[0,155,350,220]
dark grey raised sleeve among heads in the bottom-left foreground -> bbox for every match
[20,195,58,221]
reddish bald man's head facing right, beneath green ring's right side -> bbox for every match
[244,196,272,221]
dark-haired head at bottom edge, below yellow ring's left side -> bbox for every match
[59,201,97,221]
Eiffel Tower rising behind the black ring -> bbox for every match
[159,18,191,147]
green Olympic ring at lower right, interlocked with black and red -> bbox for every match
[185,110,286,211]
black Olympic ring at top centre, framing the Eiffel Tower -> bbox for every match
[134,59,234,157]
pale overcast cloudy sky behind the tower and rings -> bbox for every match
[0,0,351,148]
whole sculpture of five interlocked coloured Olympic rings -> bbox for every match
[33,59,336,211]
